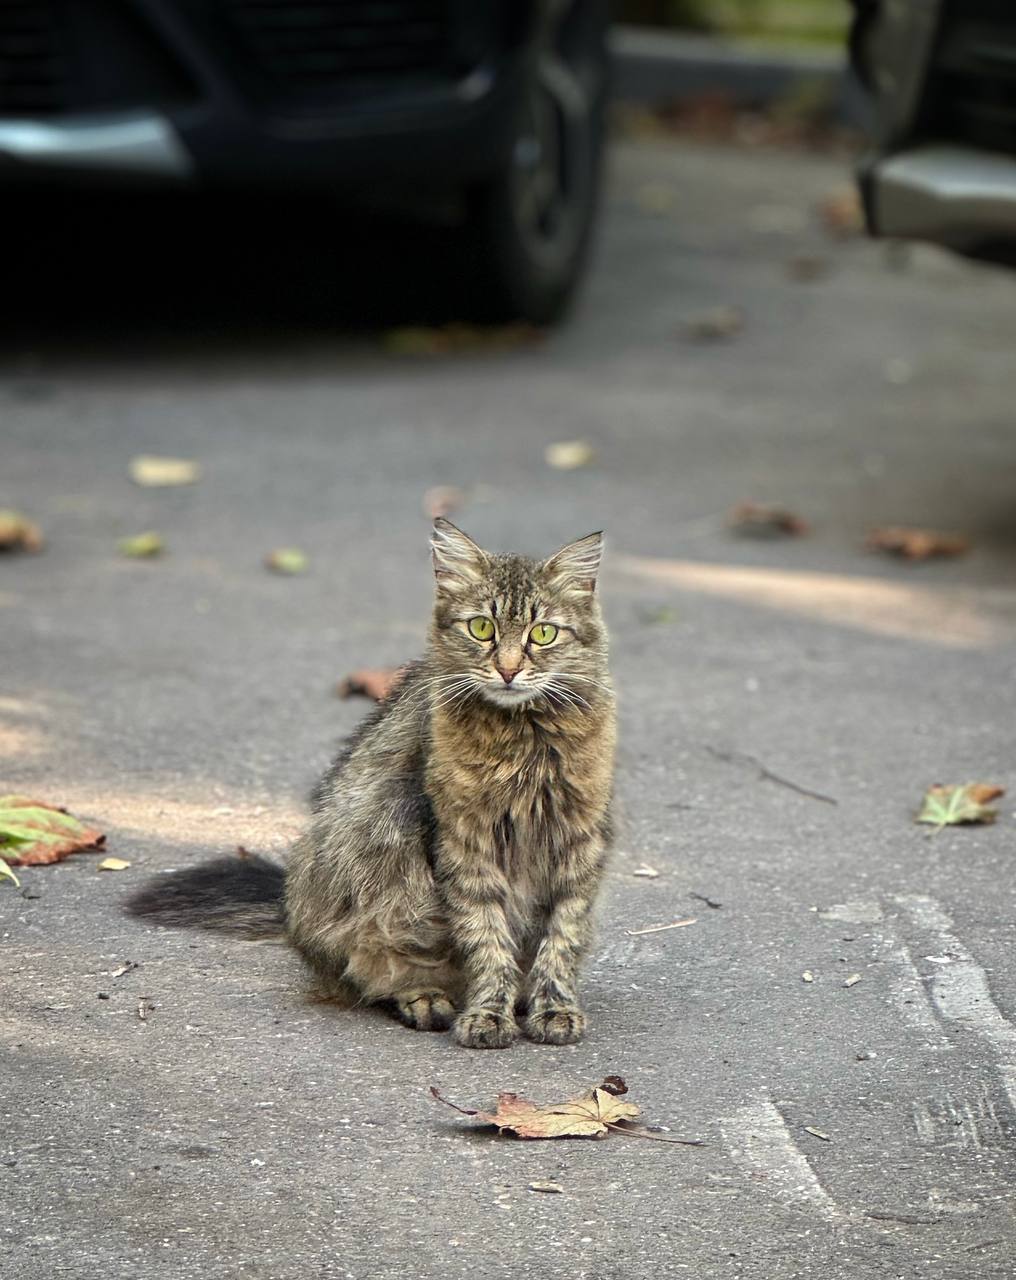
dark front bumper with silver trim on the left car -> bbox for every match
[0,0,543,189]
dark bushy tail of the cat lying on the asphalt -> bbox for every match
[124,854,285,938]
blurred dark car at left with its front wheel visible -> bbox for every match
[0,0,607,323]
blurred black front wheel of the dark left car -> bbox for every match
[467,0,608,324]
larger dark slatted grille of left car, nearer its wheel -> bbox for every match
[220,0,449,92]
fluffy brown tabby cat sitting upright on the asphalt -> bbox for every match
[128,518,615,1048]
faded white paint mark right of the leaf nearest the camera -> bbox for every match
[720,1094,850,1222]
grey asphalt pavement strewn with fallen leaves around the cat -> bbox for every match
[0,141,1016,1280]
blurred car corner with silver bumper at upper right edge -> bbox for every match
[851,0,1016,265]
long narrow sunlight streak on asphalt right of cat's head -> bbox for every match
[614,556,1016,649]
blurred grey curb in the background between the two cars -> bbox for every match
[610,24,869,127]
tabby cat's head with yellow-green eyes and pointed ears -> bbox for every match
[431,518,610,710]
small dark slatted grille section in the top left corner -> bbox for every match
[0,0,68,115]
